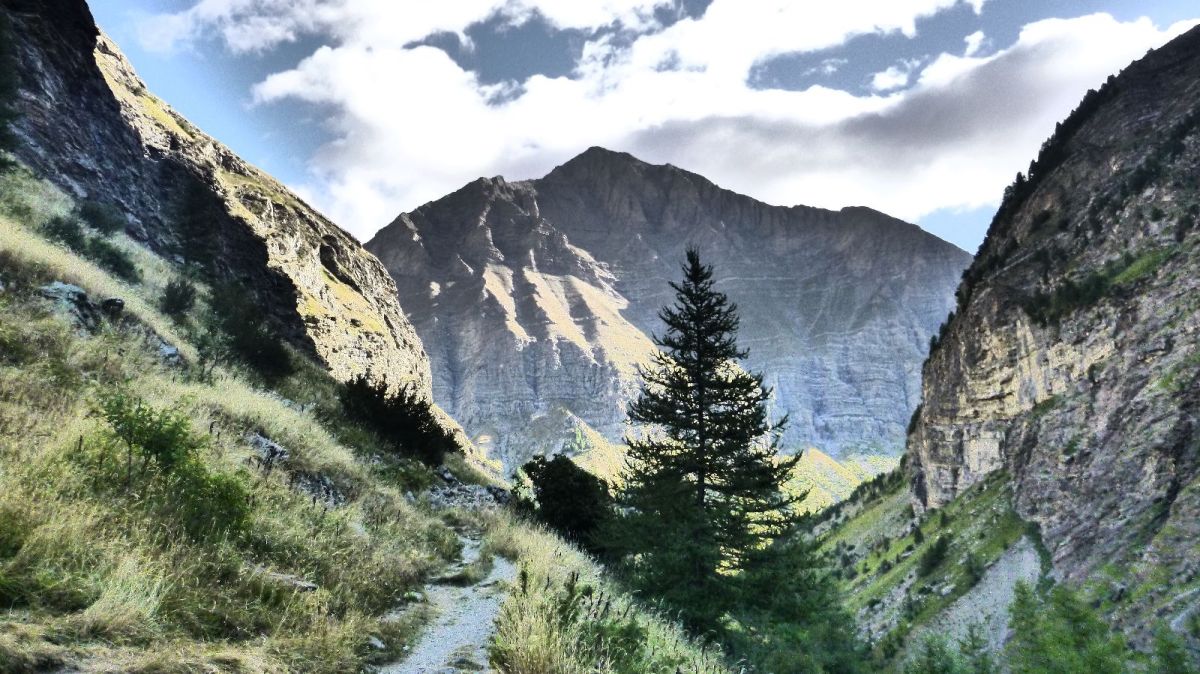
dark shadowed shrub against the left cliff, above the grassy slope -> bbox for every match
[202,283,295,381]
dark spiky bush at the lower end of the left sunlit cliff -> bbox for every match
[338,375,458,465]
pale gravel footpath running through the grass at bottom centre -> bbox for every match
[380,538,516,674]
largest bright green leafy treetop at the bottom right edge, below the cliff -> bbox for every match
[1008,583,1129,674]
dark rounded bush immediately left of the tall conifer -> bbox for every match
[521,455,613,553]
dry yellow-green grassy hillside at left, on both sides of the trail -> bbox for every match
[0,164,725,672]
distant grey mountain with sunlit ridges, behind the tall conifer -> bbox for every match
[367,148,971,468]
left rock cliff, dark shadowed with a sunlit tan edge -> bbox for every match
[0,0,430,392]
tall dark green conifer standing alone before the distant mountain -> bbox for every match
[616,251,797,626]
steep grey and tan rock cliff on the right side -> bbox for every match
[908,24,1200,632]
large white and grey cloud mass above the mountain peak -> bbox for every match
[138,0,1200,239]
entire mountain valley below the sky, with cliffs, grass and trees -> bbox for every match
[0,0,1200,674]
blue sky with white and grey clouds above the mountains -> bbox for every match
[90,0,1200,252]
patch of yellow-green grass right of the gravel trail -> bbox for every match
[484,512,731,674]
